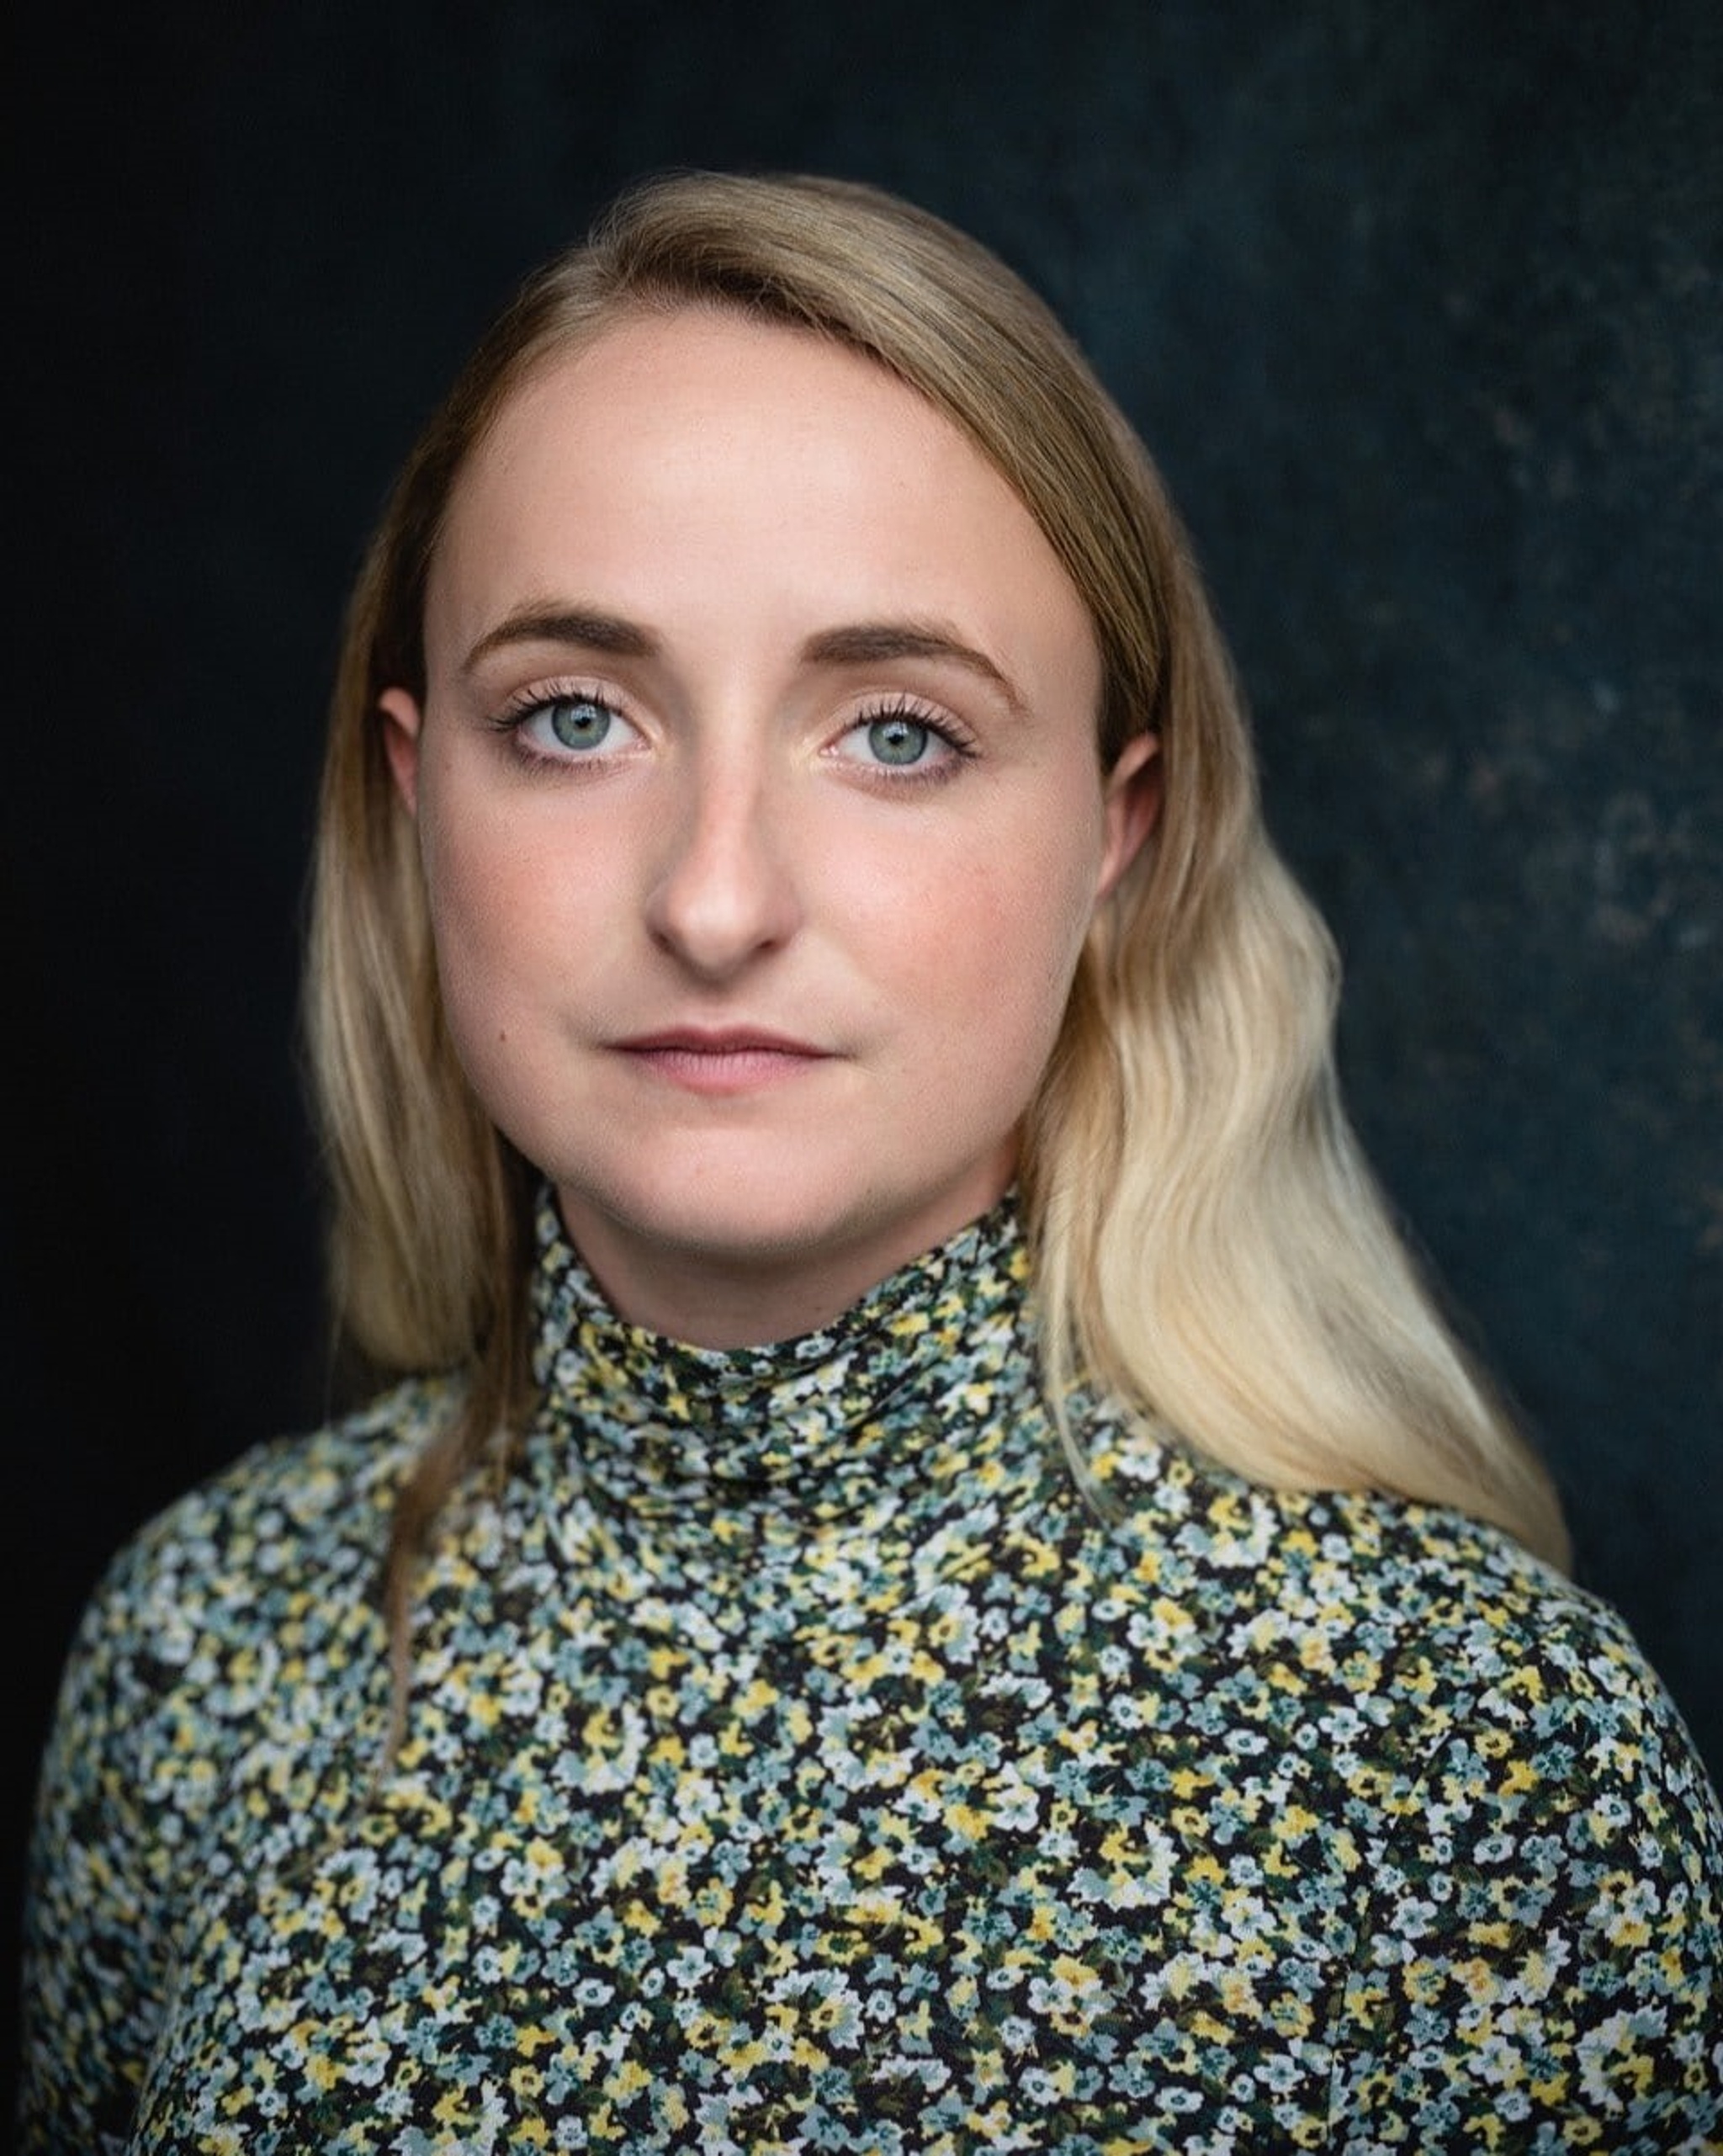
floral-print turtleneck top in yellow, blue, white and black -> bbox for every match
[24,1203,1723,2156]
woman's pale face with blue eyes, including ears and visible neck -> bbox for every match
[382,311,1156,1346]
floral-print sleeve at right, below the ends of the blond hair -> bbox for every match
[1330,1597,1723,2156]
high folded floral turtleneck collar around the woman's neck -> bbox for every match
[533,1190,1052,1533]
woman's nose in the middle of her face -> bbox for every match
[647,770,803,981]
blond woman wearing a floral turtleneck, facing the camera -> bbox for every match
[24,175,1723,2152]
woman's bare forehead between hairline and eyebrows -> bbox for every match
[427,308,1098,698]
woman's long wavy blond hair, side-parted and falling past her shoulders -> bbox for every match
[306,173,1567,1698]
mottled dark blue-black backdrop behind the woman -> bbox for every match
[0,0,1723,2104]
